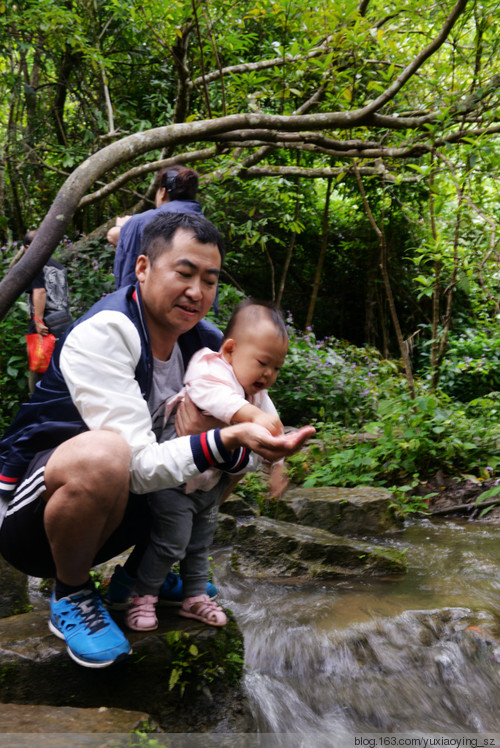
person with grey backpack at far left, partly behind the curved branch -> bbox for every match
[23,231,73,395]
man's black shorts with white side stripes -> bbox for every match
[0,449,150,578]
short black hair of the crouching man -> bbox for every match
[140,213,225,264]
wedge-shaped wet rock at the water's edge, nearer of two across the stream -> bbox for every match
[232,517,406,580]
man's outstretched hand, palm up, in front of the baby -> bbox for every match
[220,423,316,462]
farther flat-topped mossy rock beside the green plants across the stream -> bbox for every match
[275,486,402,535]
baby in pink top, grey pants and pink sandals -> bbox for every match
[125,299,288,631]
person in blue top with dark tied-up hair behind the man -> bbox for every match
[107,166,202,289]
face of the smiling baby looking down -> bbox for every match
[224,320,288,395]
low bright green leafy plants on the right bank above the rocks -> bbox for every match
[289,386,500,486]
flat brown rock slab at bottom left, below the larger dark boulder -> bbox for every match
[0,704,157,734]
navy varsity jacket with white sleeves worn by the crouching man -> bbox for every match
[0,286,250,523]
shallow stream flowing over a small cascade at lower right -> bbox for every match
[215,520,500,746]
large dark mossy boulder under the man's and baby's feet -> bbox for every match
[0,608,253,732]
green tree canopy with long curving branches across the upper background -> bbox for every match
[0,0,500,374]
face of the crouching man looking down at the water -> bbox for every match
[136,229,221,348]
